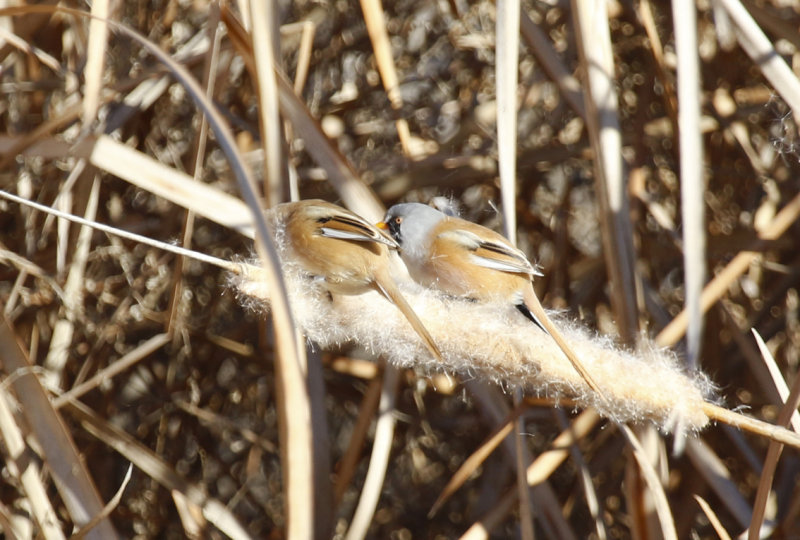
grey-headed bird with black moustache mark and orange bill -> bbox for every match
[377,203,602,396]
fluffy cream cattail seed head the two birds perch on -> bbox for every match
[235,244,712,432]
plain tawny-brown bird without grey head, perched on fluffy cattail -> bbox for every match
[271,199,442,361]
